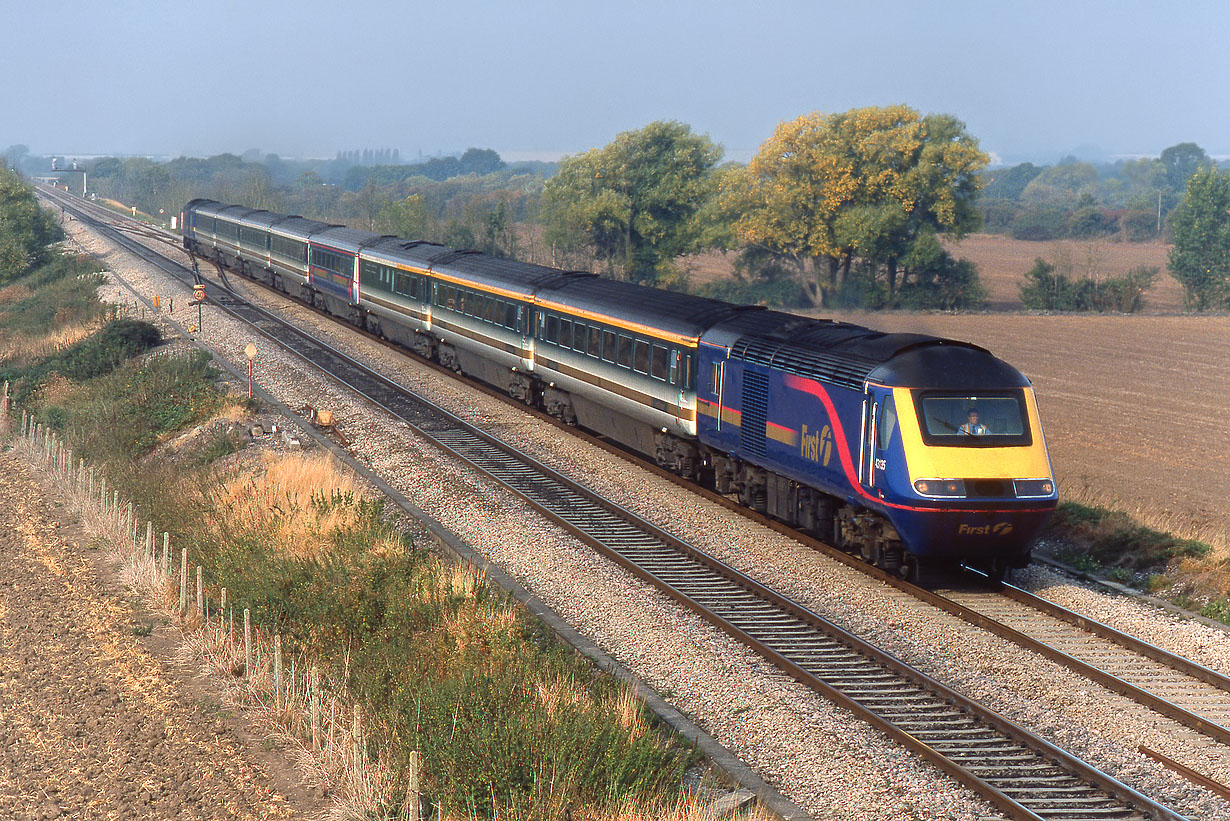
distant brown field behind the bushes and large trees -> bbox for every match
[680,234,1183,314]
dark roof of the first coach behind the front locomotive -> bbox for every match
[538,274,744,343]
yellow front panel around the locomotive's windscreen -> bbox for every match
[893,388,1053,483]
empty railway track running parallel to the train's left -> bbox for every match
[38,183,1200,819]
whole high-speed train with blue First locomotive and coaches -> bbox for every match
[181,199,1058,576]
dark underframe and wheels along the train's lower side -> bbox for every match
[188,241,998,581]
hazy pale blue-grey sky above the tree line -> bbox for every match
[0,0,1230,161]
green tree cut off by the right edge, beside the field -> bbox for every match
[1170,166,1230,310]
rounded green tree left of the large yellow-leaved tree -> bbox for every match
[542,122,722,284]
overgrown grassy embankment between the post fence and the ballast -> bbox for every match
[0,247,718,819]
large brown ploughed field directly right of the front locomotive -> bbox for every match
[817,313,1230,545]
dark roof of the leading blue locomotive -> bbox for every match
[704,311,1030,390]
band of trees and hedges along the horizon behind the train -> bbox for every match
[9,106,1230,310]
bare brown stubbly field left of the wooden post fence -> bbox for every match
[0,453,319,820]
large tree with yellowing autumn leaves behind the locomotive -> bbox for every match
[726,106,988,305]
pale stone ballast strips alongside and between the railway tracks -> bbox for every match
[52,214,1230,819]
